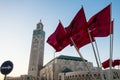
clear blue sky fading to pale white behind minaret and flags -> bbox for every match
[0,0,120,76]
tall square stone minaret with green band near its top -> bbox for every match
[28,20,45,77]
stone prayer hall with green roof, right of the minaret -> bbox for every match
[40,55,95,80]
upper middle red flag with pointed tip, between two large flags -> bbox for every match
[65,7,87,36]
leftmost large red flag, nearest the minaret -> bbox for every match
[47,22,69,52]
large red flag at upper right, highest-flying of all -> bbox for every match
[88,4,111,37]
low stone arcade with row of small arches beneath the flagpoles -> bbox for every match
[58,69,120,80]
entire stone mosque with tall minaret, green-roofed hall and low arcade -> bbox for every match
[7,21,120,80]
